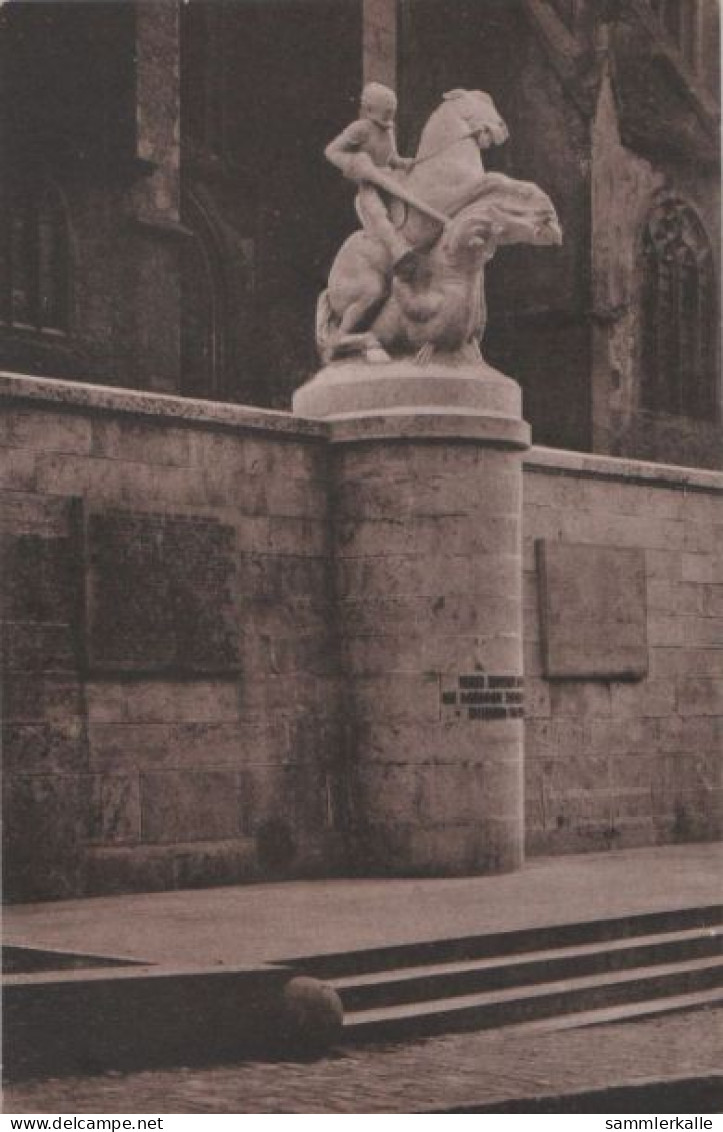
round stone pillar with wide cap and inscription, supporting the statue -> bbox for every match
[294,362,530,875]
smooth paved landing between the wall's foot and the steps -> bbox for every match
[3,844,723,967]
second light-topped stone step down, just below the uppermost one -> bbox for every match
[344,958,723,1041]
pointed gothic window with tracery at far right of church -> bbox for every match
[642,200,716,417]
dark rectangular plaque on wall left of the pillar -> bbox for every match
[85,509,239,674]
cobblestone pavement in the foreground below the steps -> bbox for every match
[6,1010,723,1115]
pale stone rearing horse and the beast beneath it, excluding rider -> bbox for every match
[317,91,561,363]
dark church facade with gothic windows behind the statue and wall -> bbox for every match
[0,0,723,466]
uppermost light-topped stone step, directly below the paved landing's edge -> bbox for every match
[329,927,723,1011]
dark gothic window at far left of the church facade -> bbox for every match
[0,186,70,333]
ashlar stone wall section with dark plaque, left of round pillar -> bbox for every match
[1,378,339,900]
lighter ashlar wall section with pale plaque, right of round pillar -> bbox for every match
[524,448,723,854]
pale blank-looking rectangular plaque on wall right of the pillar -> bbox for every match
[535,539,647,680]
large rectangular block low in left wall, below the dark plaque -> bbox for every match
[140,770,241,843]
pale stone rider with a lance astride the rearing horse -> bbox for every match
[324,83,415,276]
